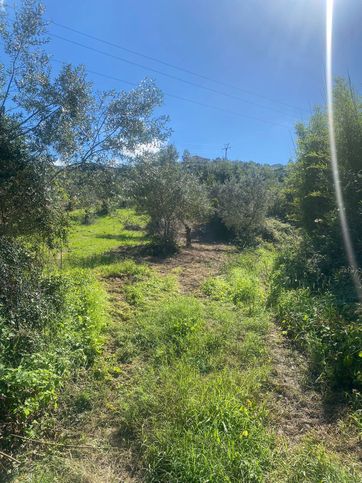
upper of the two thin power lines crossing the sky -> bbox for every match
[50,20,306,115]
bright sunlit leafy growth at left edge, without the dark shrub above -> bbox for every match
[0,271,107,425]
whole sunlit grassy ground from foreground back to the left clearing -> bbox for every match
[12,210,362,483]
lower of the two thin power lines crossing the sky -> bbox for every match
[50,34,300,118]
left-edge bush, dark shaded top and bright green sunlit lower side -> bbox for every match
[0,242,106,424]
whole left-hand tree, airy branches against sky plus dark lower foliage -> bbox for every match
[0,0,167,246]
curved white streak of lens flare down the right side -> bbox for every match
[326,0,362,302]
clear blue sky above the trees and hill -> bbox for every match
[39,0,362,163]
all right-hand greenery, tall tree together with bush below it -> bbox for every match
[270,80,362,398]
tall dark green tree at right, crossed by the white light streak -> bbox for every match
[286,80,362,290]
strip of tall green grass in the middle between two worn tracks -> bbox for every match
[109,248,274,482]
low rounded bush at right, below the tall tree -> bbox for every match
[269,238,362,390]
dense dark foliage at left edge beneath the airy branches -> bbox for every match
[0,121,66,245]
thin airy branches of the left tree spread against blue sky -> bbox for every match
[0,0,168,170]
